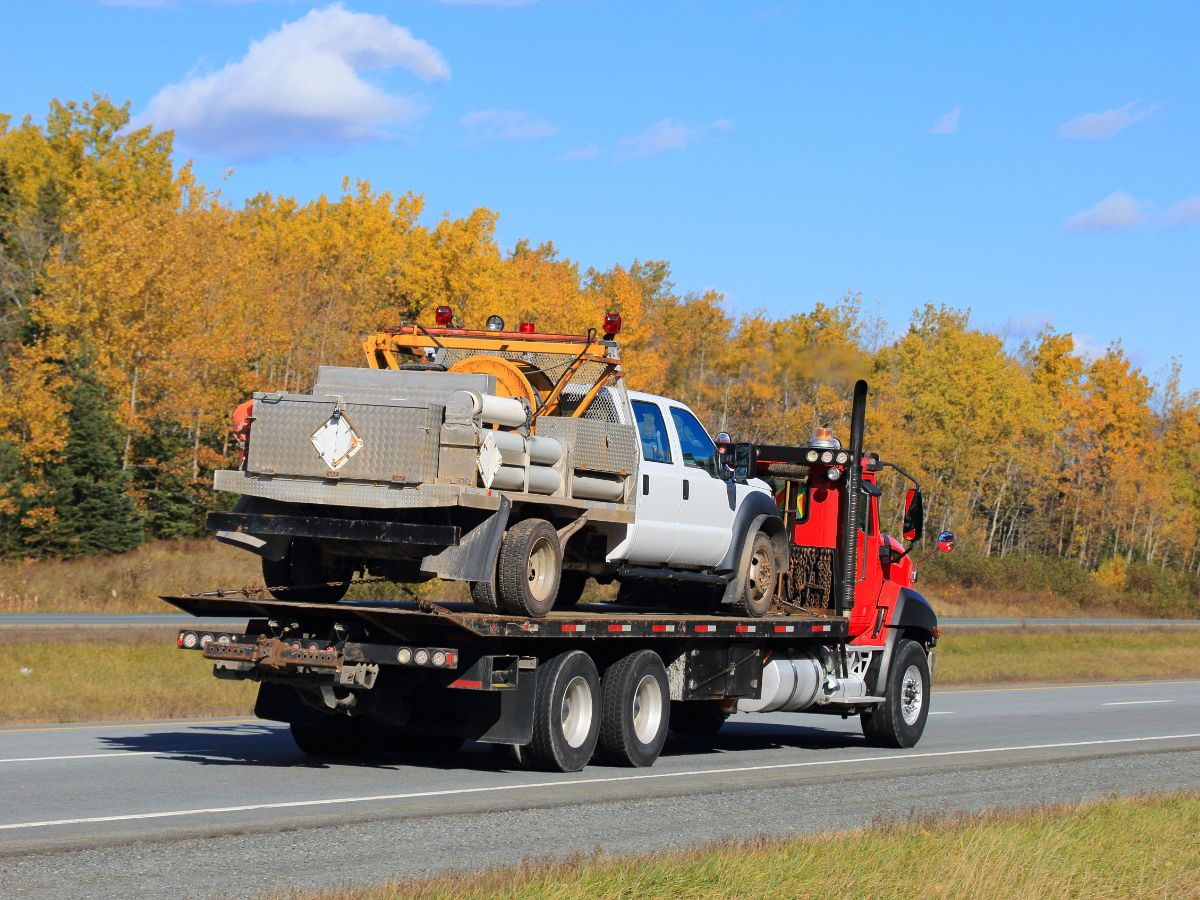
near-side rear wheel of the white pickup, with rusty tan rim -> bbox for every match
[496,518,563,619]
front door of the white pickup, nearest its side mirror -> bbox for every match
[668,406,737,565]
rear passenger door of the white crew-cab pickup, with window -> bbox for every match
[613,400,683,565]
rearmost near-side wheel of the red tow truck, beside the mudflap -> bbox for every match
[520,650,600,772]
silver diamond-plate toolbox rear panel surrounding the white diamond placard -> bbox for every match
[246,394,444,485]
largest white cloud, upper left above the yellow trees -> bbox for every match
[136,4,450,158]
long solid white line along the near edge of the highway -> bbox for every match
[0,732,1200,832]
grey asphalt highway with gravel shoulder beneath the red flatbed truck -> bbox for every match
[0,682,1200,898]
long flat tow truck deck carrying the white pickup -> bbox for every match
[162,592,847,641]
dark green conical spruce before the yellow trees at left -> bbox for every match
[37,361,144,557]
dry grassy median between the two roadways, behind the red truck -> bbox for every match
[0,626,1200,725]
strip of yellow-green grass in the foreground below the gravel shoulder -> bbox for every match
[282,792,1200,900]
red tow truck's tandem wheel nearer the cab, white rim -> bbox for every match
[600,650,671,766]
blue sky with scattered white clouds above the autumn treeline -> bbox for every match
[0,0,1200,386]
